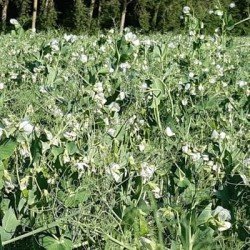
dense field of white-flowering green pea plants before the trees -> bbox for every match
[0,17,250,250]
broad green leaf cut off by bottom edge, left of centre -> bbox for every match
[42,236,73,250]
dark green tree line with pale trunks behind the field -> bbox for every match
[0,0,250,35]
